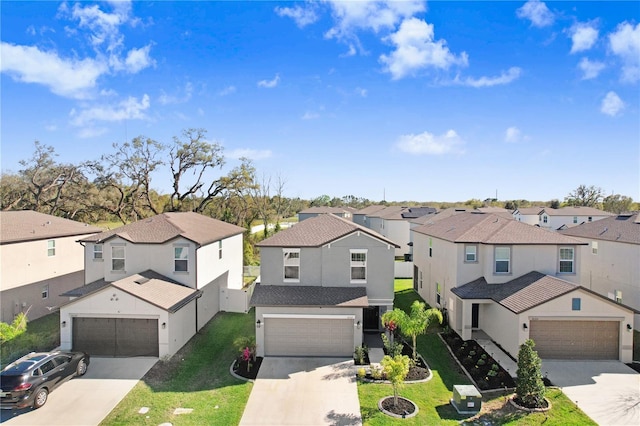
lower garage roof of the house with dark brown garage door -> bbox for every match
[61,270,202,313]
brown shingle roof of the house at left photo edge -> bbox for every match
[0,210,102,244]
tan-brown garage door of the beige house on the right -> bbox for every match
[529,320,620,359]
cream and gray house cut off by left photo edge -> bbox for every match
[0,210,102,323]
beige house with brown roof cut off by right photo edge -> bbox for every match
[560,212,640,329]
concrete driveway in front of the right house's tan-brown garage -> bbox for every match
[542,360,640,426]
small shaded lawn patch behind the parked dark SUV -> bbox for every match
[0,312,60,366]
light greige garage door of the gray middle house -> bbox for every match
[264,318,355,357]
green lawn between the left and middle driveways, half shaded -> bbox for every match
[101,310,254,425]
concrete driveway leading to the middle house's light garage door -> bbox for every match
[240,357,362,426]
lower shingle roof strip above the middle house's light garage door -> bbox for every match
[251,284,369,308]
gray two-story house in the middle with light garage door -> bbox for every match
[251,214,397,356]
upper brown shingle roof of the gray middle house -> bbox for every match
[256,214,400,247]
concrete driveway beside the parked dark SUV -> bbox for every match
[0,357,158,426]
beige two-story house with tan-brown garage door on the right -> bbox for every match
[413,212,634,362]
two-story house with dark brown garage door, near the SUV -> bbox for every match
[60,213,248,356]
